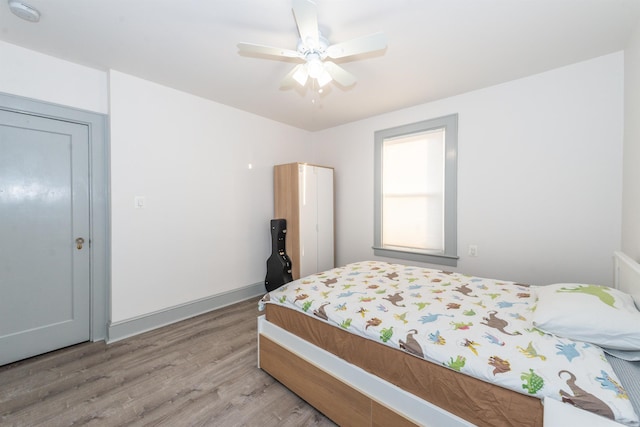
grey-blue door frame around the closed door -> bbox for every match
[0,92,111,341]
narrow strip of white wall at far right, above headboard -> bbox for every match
[622,23,640,261]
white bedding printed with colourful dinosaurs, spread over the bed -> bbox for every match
[261,261,640,426]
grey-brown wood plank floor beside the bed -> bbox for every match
[0,299,334,426]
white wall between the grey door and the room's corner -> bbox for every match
[109,71,310,322]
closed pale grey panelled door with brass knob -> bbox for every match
[0,110,90,365]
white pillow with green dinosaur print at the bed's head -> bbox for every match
[531,283,640,350]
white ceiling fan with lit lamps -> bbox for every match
[238,0,387,88]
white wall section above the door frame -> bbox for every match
[0,41,108,114]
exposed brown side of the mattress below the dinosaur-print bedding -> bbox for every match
[265,304,543,427]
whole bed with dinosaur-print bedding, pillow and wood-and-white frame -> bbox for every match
[258,253,640,426]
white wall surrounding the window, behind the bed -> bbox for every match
[312,52,624,284]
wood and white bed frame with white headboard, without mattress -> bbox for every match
[258,252,640,427]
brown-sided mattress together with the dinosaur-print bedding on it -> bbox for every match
[264,261,638,425]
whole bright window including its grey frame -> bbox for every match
[373,114,458,266]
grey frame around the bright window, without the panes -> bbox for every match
[372,114,459,267]
